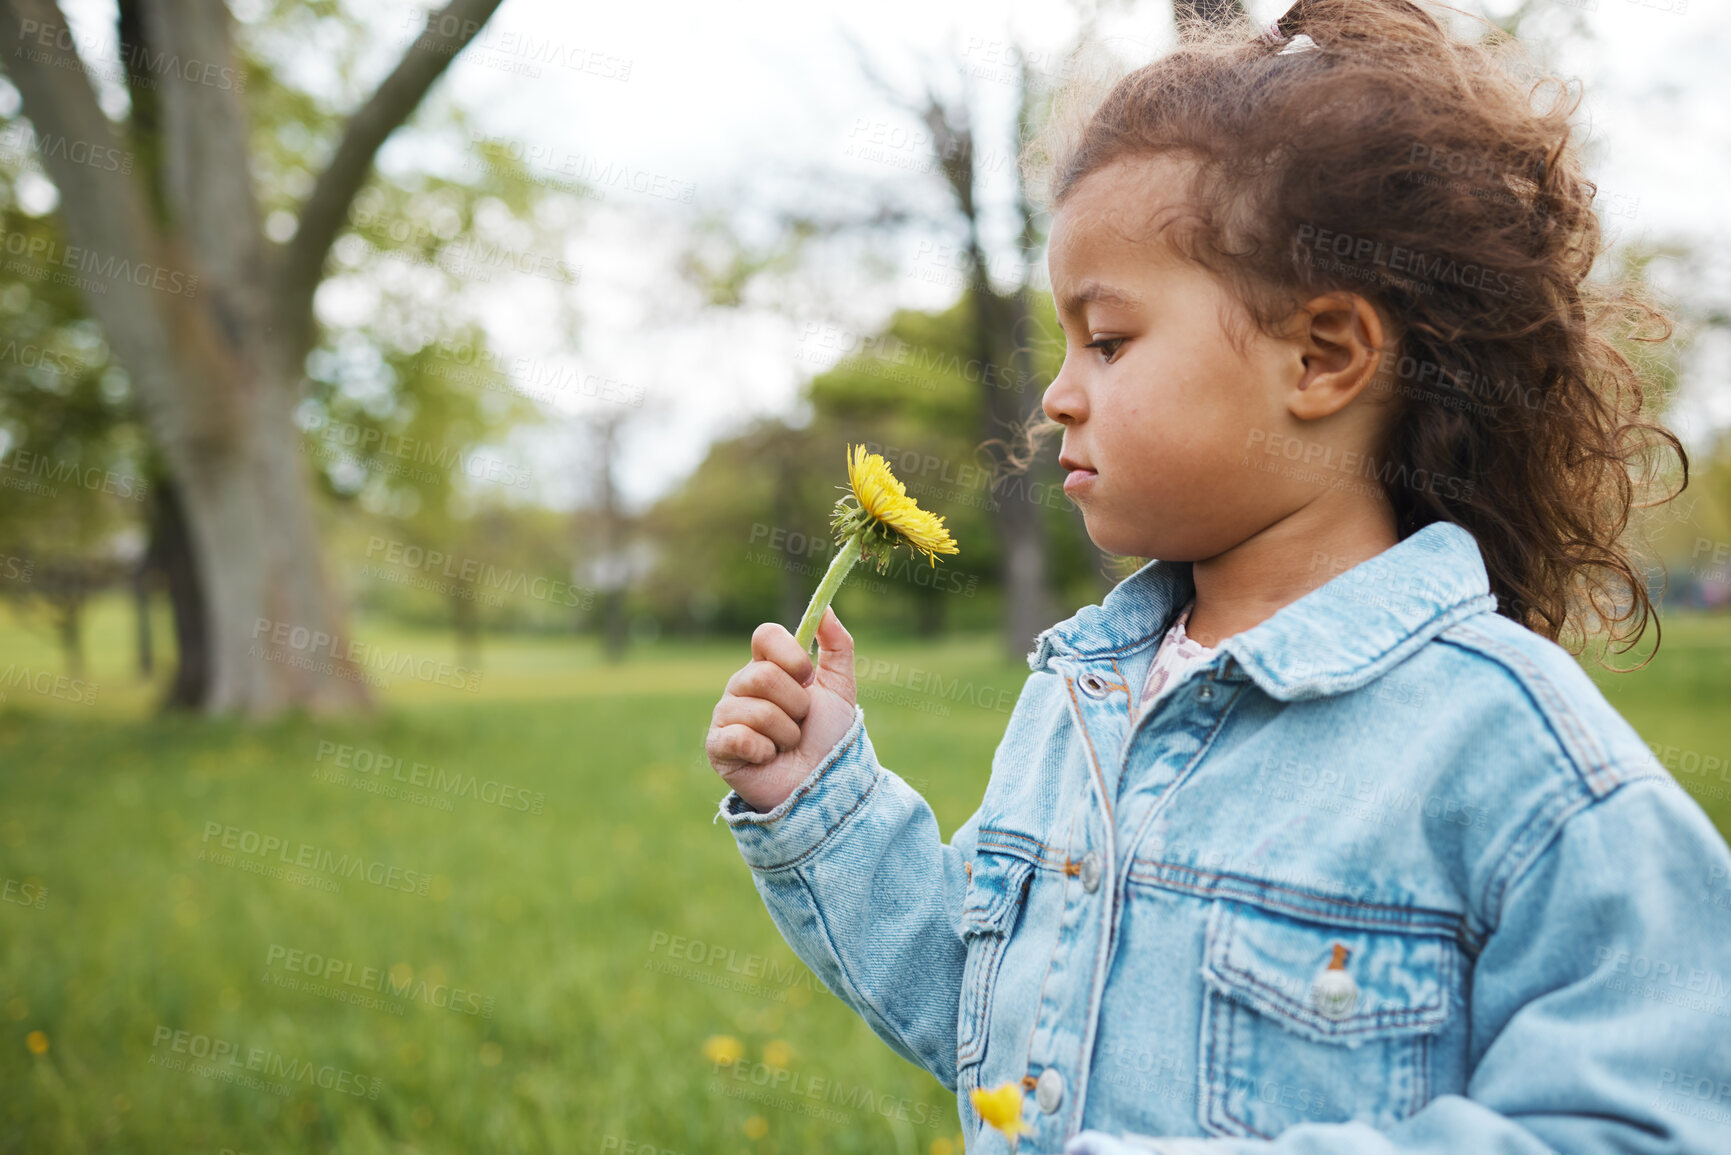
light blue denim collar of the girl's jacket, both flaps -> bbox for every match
[1028,521,1496,701]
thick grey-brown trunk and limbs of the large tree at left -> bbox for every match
[0,0,499,715]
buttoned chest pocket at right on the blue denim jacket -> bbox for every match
[1198,899,1456,1139]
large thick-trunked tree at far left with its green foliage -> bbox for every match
[0,0,588,713]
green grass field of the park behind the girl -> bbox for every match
[0,604,1731,1155]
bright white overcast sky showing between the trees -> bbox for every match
[54,0,1731,506]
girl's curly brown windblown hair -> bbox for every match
[1013,0,1688,649]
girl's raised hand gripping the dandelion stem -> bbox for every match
[705,610,855,814]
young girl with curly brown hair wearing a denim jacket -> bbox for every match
[706,0,1731,1155]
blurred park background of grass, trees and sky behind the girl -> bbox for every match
[0,0,1731,1155]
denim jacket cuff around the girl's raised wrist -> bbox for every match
[717,703,878,871]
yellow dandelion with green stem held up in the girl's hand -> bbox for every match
[793,445,961,649]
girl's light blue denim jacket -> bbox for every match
[718,523,1731,1155]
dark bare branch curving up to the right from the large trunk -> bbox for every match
[277,0,500,350]
